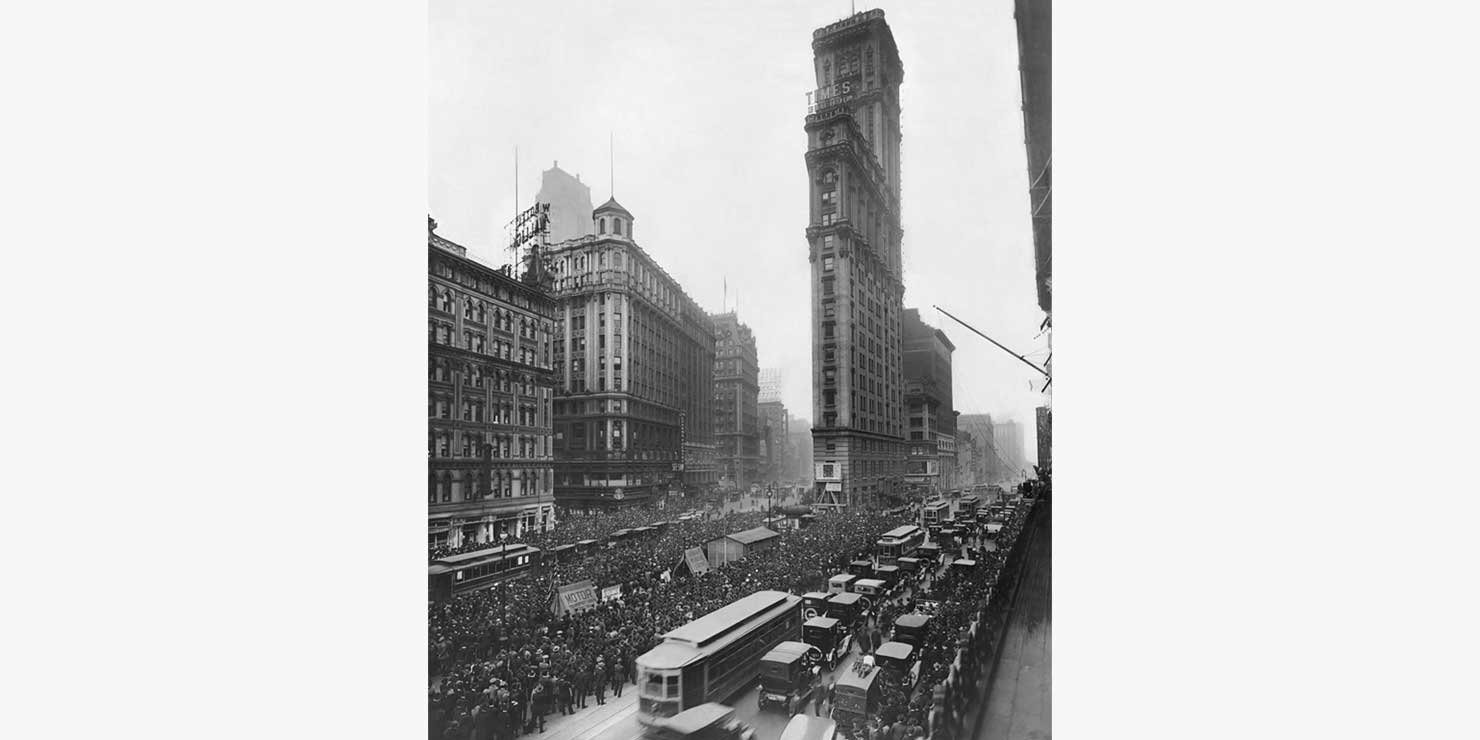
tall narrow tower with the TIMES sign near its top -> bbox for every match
[805,10,906,506]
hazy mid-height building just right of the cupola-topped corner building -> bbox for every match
[713,311,761,488]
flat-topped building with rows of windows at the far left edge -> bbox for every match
[426,218,555,549]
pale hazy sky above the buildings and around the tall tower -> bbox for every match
[428,0,1048,460]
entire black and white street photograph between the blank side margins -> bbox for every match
[426,0,1052,740]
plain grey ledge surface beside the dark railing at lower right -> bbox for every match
[974,512,1054,740]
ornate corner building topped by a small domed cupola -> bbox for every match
[548,198,718,509]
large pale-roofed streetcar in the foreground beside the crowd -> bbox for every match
[636,591,802,725]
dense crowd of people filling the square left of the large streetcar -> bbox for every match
[428,497,904,740]
